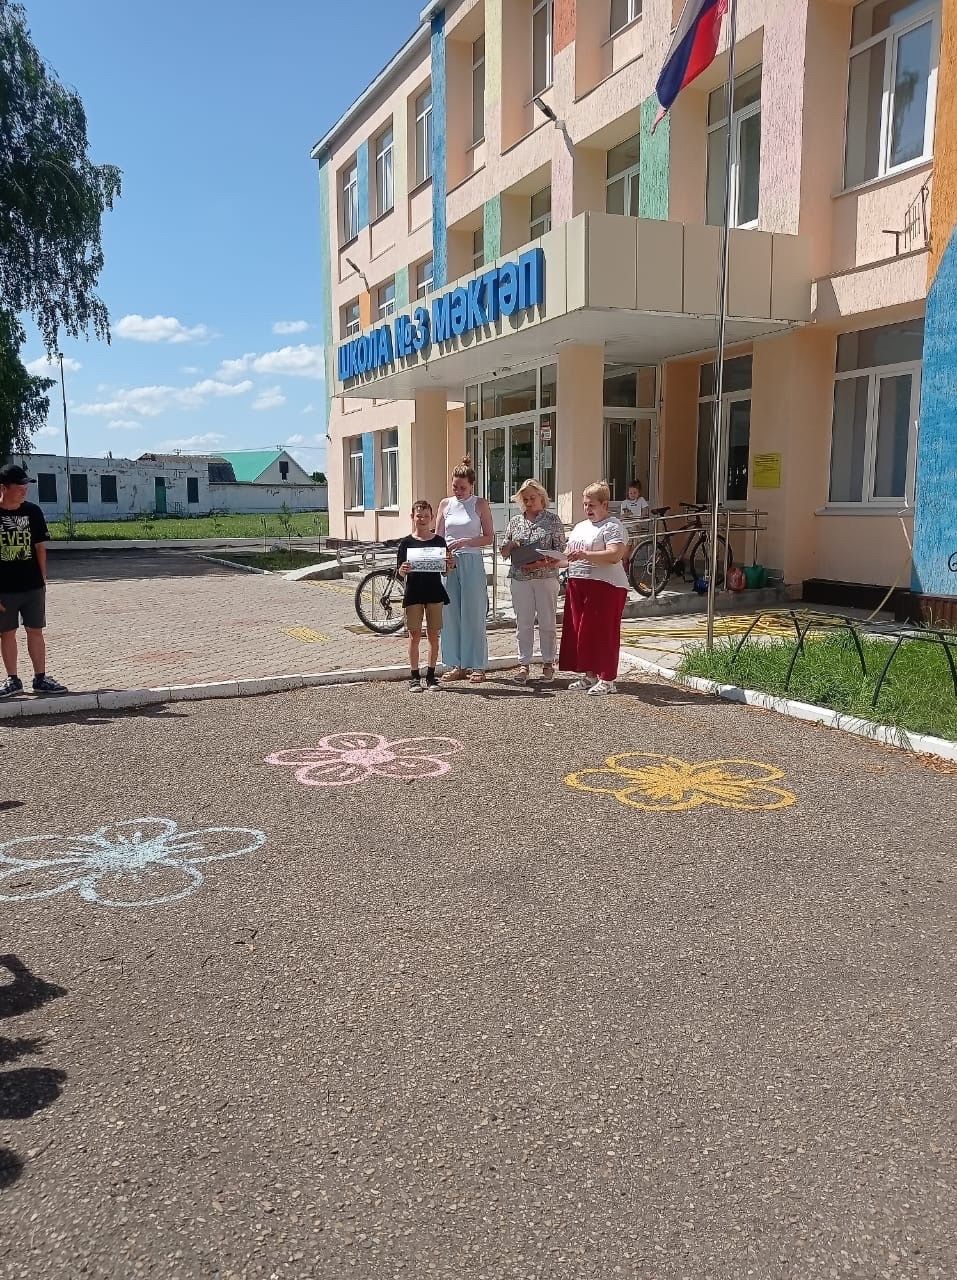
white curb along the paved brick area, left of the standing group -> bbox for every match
[0,657,518,721]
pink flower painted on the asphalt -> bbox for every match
[266,733,464,787]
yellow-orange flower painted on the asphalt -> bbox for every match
[566,751,796,813]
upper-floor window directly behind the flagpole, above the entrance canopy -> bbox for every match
[708,67,761,227]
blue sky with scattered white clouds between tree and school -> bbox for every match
[18,0,422,470]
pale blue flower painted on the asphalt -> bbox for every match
[0,818,266,906]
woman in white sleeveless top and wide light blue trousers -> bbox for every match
[435,458,494,685]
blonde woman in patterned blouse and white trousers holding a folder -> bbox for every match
[499,480,566,685]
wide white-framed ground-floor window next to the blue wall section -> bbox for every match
[828,319,924,506]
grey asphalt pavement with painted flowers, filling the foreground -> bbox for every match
[0,678,957,1280]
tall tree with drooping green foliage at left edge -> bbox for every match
[0,0,120,457]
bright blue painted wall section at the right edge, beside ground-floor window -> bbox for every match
[912,230,957,596]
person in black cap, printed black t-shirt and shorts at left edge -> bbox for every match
[0,462,67,698]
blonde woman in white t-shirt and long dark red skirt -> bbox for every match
[558,480,628,694]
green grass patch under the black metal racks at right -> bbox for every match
[679,636,957,740]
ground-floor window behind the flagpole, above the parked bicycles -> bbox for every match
[695,356,752,506]
